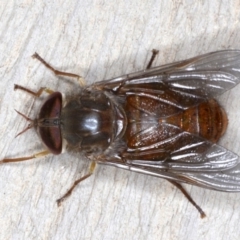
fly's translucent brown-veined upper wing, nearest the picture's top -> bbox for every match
[90,50,240,109]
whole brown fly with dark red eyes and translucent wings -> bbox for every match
[0,50,240,217]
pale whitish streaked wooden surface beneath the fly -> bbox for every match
[0,0,240,240]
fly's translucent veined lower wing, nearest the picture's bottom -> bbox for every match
[100,125,240,192]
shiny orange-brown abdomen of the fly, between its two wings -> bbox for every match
[124,95,228,160]
